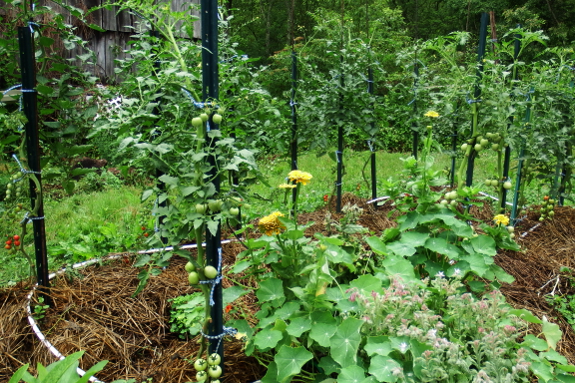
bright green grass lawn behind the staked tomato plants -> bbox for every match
[0,150,568,286]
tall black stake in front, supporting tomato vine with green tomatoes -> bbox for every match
[198,0,224,366]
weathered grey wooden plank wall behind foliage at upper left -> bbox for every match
[0,0,201,83]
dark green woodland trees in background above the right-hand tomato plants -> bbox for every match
[225,0,575,63]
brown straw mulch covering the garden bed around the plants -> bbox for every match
[0,195,575,383]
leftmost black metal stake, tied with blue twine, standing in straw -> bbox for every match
[18,26,51,305]
